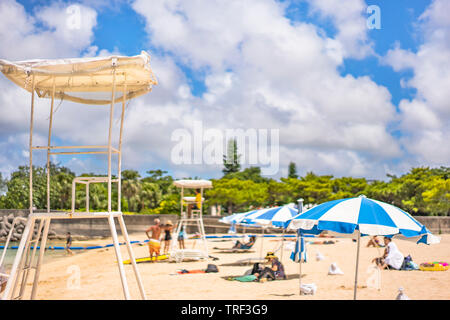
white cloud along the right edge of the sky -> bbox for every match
[385,0,450,166]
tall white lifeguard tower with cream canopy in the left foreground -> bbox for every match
[0,51,157,300]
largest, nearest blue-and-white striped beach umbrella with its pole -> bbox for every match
[285,195,439,299]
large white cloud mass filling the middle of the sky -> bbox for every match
[128,0,401,176]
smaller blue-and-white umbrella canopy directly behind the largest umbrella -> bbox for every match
[241,205,298,227]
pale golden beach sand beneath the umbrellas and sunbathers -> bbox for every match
[12,234,450,300]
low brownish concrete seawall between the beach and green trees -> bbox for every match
[0,209,450,238]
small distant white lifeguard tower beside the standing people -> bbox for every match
[169,180,213,262]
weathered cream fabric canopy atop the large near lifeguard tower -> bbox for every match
[0,51,158,105]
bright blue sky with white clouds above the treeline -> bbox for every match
[0,0,449,178]
